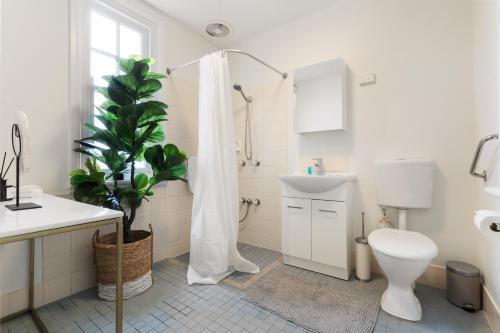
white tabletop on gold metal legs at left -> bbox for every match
[0,194,123,238]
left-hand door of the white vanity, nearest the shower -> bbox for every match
[282,198,311,260]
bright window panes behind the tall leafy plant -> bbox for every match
[88,1,150,172]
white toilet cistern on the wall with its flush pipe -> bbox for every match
[375,159,434,230]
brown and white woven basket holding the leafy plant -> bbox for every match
[92,225,153,301]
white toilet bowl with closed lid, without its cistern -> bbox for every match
[368,229,438,321]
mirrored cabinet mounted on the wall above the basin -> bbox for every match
[294,58,347,133]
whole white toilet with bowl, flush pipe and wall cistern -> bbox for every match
[368,160,438,321]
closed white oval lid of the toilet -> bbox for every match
[368,228,438,260]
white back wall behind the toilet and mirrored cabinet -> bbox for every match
[231,0,481,265]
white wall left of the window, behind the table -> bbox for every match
[0,0,70,306]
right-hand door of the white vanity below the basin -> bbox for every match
[311,200,350,268]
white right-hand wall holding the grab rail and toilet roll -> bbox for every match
[473,0,500,316]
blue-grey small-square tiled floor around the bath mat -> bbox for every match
[1,243,491,333]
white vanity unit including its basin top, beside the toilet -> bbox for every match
[280,172,355,280]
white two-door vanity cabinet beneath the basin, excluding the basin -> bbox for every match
[282,178,352,280]
